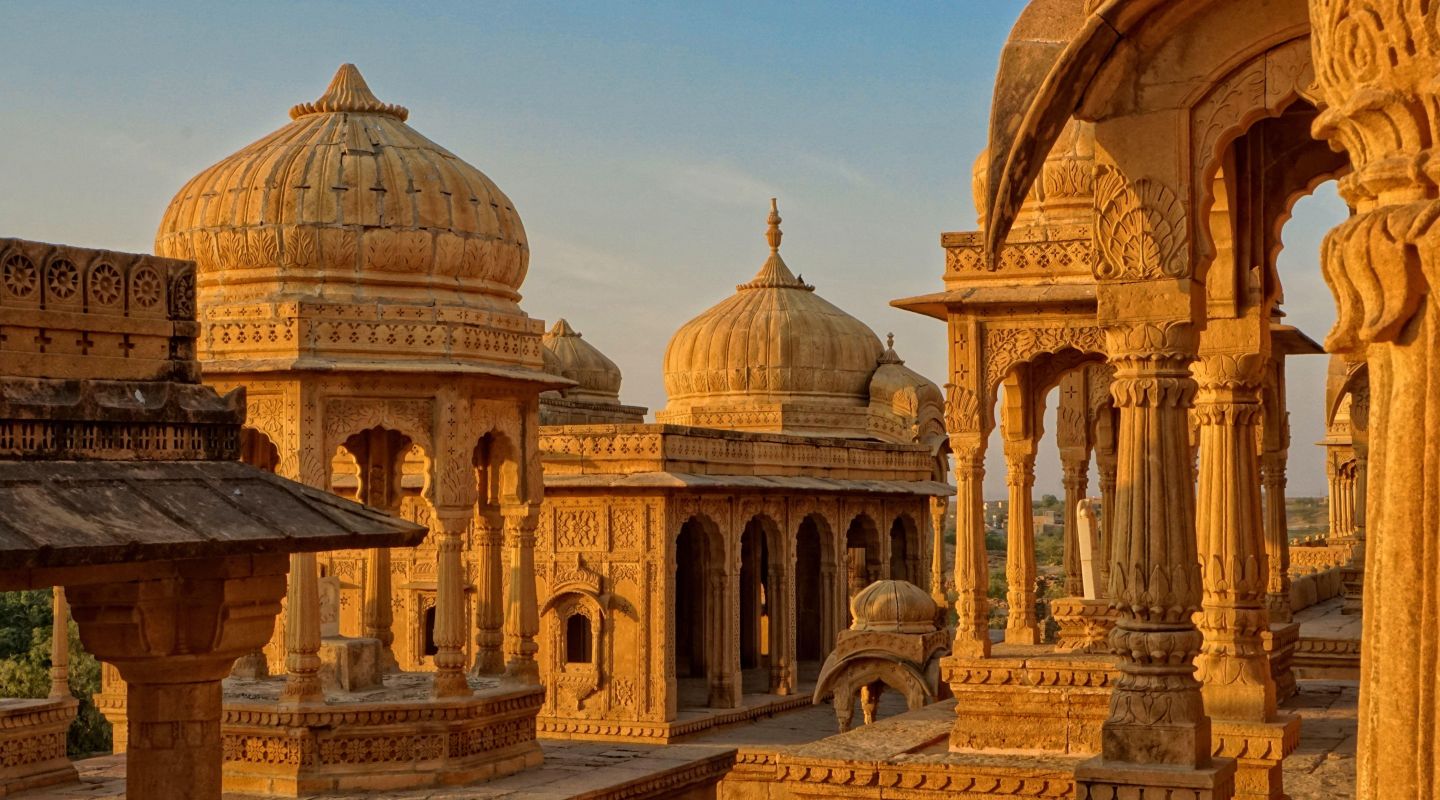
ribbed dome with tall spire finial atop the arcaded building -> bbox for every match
[662,200,883,427]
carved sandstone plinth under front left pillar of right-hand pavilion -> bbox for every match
[940,646,1119,755]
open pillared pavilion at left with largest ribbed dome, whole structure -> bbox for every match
[110,65,572,796]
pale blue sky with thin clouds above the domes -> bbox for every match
[0,0,1339,496]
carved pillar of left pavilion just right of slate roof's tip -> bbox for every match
[431,508,474,698]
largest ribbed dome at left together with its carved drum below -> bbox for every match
[156,63,543,371]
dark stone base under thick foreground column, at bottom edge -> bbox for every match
[1074,758,1236,800]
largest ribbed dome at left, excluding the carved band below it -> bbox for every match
[156,63,530,312]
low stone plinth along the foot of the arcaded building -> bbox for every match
[536,692,815,744]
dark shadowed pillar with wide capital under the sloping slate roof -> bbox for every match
[69,555,285,800]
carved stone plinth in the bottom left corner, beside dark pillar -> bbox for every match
[0,698,79,797]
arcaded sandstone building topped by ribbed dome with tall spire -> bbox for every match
[536,201,950,742]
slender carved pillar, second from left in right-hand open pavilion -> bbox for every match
[1005,442,1040,645]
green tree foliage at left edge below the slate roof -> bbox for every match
[0,588,111,757]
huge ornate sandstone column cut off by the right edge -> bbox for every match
[1310,10,1440,800]
